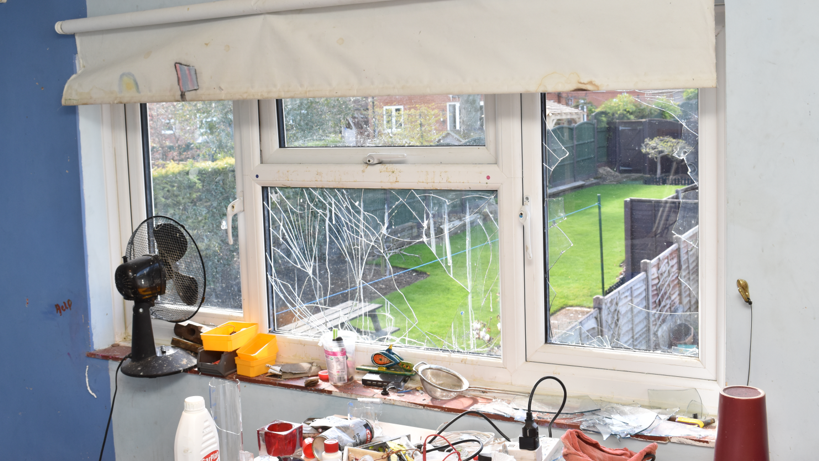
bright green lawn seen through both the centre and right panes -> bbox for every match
[352,184,680,347]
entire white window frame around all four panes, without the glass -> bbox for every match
[91,12,725,404]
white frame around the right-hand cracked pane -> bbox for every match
[523,89,720,382]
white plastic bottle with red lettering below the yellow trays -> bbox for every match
[173,395,219,461]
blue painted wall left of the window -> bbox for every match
[0,0,113,460]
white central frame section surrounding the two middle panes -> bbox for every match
[253,95,523,378]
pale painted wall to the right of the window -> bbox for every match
[725,0,819,461]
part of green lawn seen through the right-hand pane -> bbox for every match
[549,183,682,313]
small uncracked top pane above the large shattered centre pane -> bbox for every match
[279,94,486,147]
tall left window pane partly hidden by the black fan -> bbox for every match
[145,101,242,310]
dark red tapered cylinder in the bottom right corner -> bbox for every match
[714,386,769,461]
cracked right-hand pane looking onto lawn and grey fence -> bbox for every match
[543,89,699,357]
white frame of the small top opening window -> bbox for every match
[262,95,498,165]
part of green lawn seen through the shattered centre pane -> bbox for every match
[352,221,500,348]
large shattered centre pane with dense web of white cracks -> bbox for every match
[264,187,501,355]
